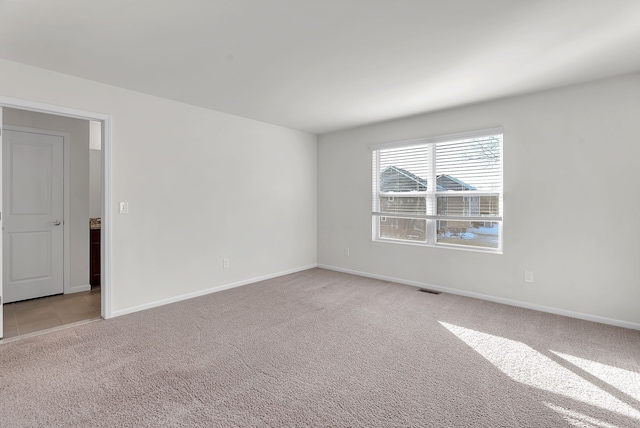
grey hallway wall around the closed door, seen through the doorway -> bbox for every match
[3,108,90,293]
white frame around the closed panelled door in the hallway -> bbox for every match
[0,123,71,302]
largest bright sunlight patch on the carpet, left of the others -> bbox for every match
[439,321,640,420]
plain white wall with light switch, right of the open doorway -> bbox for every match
[0,60,317,314]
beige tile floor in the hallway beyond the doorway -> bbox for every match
[3,287,100,339]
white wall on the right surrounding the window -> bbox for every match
[318,74,640,327]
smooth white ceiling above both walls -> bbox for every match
[0,0,640,134]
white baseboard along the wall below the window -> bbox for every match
[318,264,640,330]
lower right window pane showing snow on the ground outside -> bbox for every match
[436,220,500,248]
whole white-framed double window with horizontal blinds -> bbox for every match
[372,129,503,252]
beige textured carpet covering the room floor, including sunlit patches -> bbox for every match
[0,269,640,428]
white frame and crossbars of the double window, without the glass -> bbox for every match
[369,127,504,254]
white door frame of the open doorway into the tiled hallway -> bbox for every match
[0,96,113,320]
